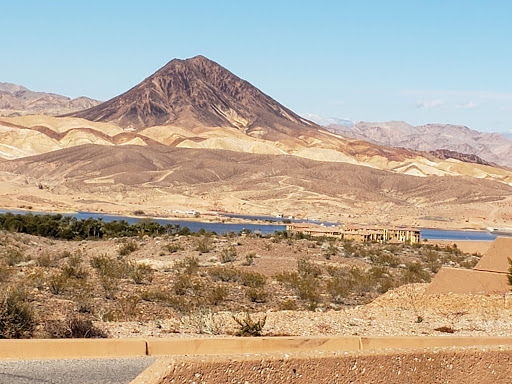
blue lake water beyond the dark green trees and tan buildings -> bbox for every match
[0,210,496,241]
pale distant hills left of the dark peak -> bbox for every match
[0,82,100,116]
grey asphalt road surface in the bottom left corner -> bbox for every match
[0,357,155,384]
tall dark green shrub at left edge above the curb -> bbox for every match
[0,287,37,339]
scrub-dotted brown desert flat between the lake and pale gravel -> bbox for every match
[0,227,488,337]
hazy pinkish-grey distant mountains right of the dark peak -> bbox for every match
[326,121,512,167]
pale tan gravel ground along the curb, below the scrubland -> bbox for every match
[102,284,512,337]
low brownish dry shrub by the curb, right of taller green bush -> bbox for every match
[44,316,108,339]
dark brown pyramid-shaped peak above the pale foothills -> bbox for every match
[68,56,319,138]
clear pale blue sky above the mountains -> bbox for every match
[0,0,512,132]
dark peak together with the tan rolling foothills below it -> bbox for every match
[0,56,512,228]
